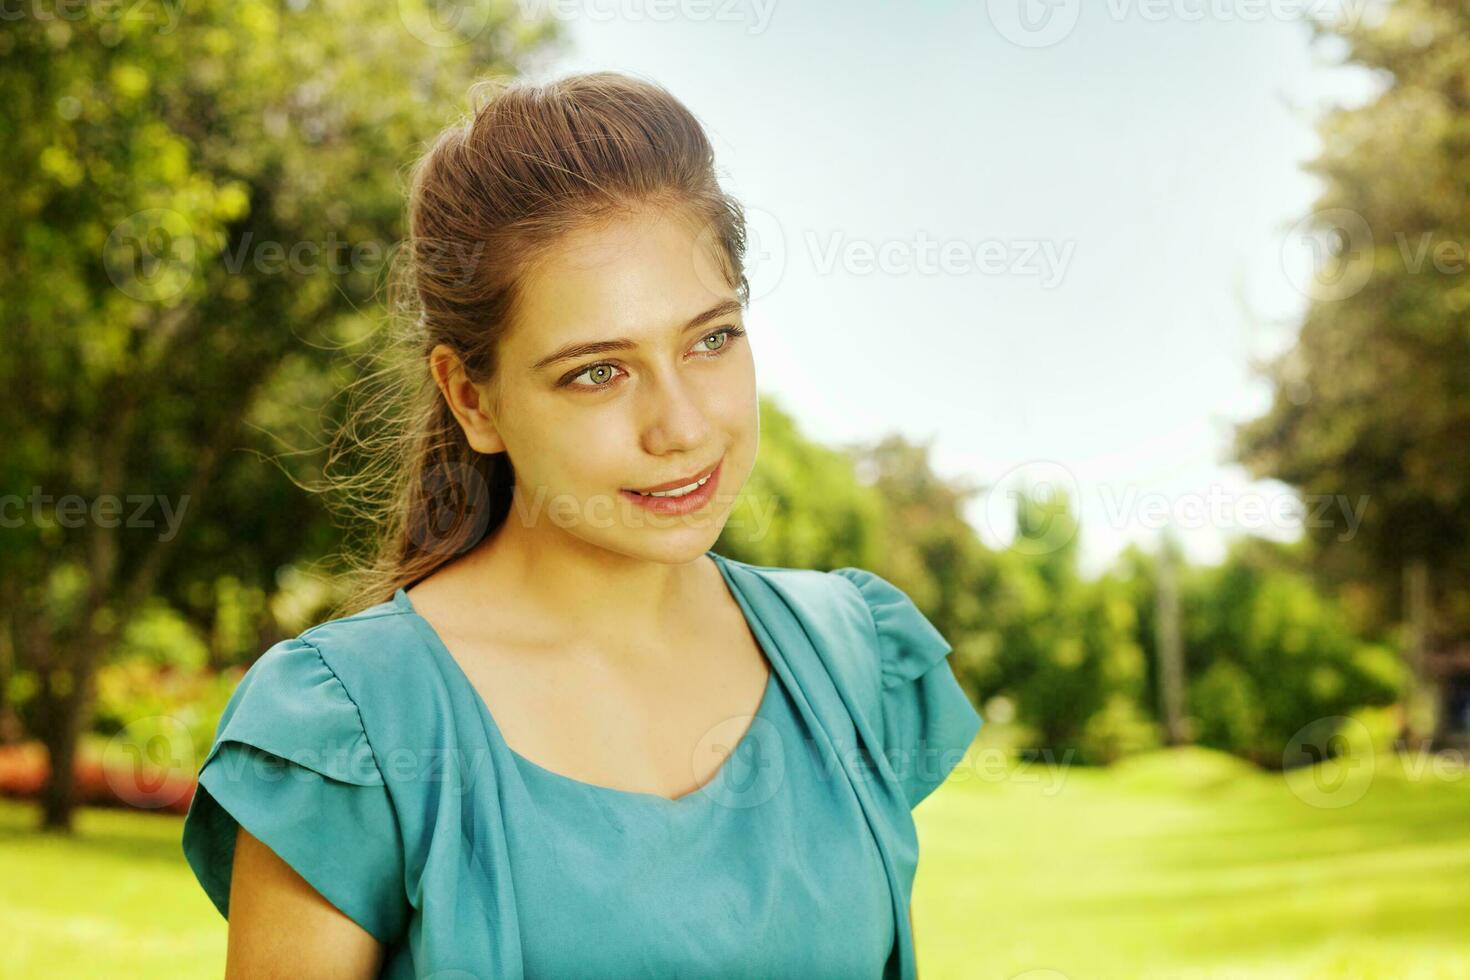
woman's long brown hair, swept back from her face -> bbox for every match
[326,72,750,617]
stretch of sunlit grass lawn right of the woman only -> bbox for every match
[914,749,1470,980]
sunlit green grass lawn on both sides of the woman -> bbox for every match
[0,749,1470,980]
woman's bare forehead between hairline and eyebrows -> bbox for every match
[506,210,735,354]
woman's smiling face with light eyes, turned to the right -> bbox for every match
[472,210,760,563]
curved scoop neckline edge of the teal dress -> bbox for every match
[392,551,781,810]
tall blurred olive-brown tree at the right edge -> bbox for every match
[1236,0,1470,735]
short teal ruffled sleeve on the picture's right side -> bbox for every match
[832,567,982,810]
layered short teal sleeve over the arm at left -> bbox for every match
[182,636,409,943]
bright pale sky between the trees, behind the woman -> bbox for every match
[528,0,1373,573]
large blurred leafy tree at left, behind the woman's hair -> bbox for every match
[0,0,559,827]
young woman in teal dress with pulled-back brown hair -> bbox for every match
[182,72,980,980]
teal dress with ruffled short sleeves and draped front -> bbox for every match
[182,551,980,980]
